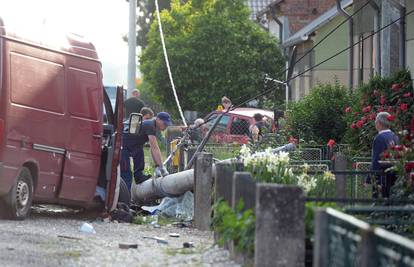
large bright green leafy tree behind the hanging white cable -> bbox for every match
[141,0,283,115]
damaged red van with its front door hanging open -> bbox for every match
[0,19,123,219]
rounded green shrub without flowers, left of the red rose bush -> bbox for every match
[287,83,350,144]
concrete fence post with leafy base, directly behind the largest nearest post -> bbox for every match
[232,172,256,212]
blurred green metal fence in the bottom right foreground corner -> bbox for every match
[314,208,414,267]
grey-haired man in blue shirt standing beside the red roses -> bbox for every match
[367,112,399,197]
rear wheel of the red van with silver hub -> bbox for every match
[4,167,33,220]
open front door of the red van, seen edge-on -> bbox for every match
[106,86,124,210]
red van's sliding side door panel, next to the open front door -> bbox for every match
[59,62,103,202]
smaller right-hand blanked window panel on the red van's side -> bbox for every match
[68,68,102,120]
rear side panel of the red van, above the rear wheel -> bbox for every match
[0,39,67,199]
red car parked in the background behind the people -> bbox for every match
[204,108,274,144]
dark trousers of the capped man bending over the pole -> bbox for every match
[120,147,147,190]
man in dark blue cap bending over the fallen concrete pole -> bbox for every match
[120,112,172,189]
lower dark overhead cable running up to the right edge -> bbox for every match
[232,9,414,109]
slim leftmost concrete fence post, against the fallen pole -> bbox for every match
[194,153,213,231]
